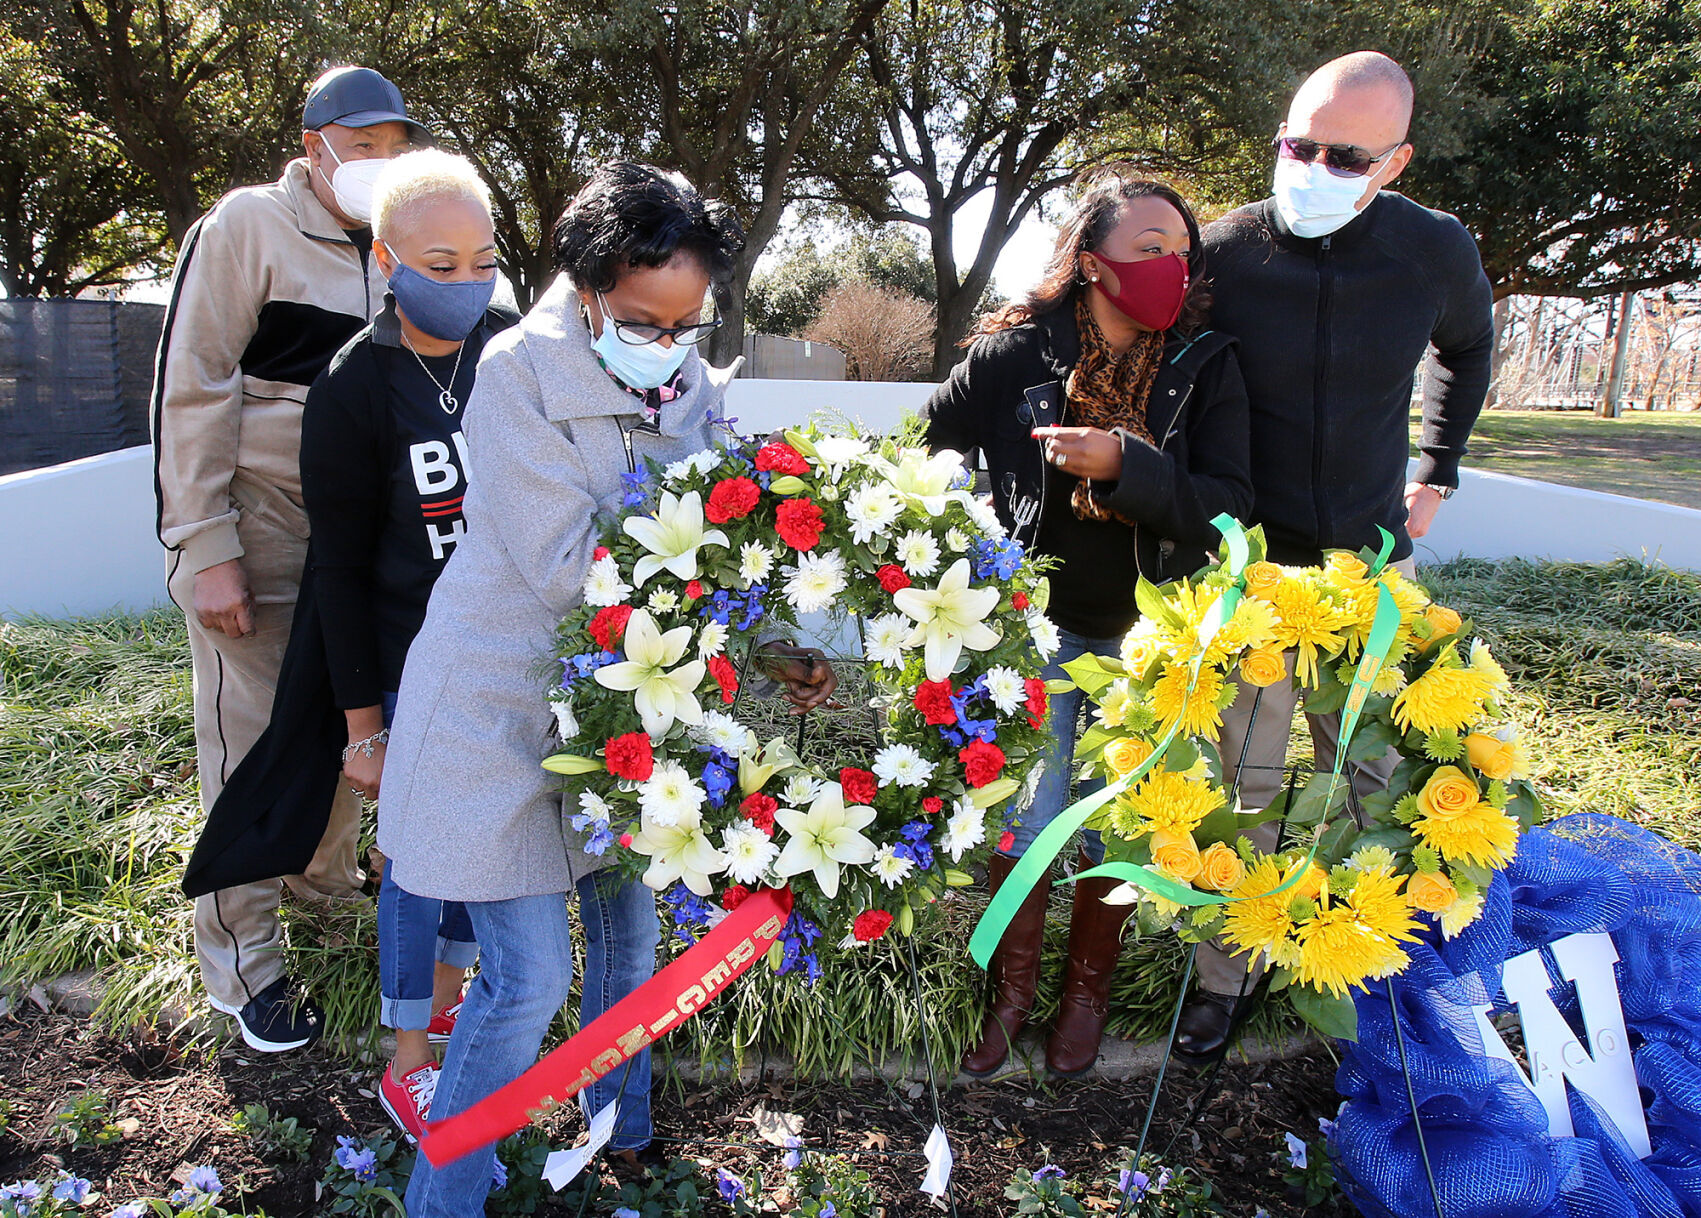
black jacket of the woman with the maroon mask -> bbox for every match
[922,299,1252,638]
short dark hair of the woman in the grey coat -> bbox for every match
[555,160,743,293]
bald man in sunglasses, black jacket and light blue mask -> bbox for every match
[1177,51,1493,1058]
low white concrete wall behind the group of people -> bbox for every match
[0,379,1701,618]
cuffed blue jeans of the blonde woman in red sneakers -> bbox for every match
[378,692,478,1033]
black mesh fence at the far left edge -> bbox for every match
[0,299,165,475]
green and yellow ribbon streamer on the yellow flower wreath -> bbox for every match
[968,514,1400,968]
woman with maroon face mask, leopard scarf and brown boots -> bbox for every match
[917,167,1252,1075]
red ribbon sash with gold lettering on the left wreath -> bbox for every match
[420,888,791,1167]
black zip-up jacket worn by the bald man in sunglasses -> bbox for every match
[1204,191,1493,565]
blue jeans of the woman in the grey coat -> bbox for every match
[407,871,660,1218]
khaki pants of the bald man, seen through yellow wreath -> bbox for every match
[1194,558,1415,993]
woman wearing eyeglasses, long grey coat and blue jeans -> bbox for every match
[379,163,840,1218]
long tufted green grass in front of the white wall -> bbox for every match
[0,560,1701,1077]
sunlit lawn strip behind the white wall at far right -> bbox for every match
[1412,410,1701,507]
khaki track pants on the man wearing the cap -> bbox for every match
[167,515,364,1007]
